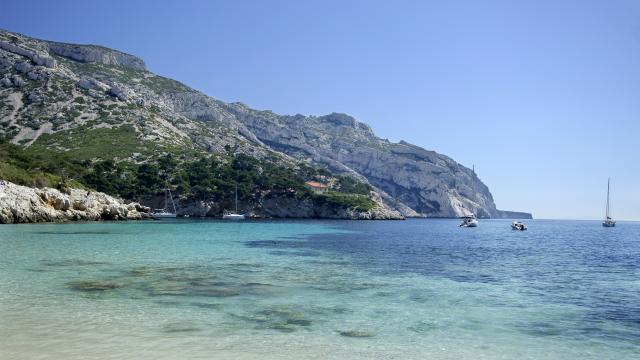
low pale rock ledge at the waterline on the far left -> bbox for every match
[0,180,150,224]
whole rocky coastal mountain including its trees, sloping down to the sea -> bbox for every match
[0,30,531,222]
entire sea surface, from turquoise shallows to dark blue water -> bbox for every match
[0,220,640,359]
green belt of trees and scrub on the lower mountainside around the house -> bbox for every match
[0,131,375,215]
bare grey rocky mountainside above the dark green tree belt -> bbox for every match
[0,31,528,218]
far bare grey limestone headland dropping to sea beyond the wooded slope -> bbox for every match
[212,104,498,217]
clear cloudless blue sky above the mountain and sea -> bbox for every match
[0,0,640,220]
